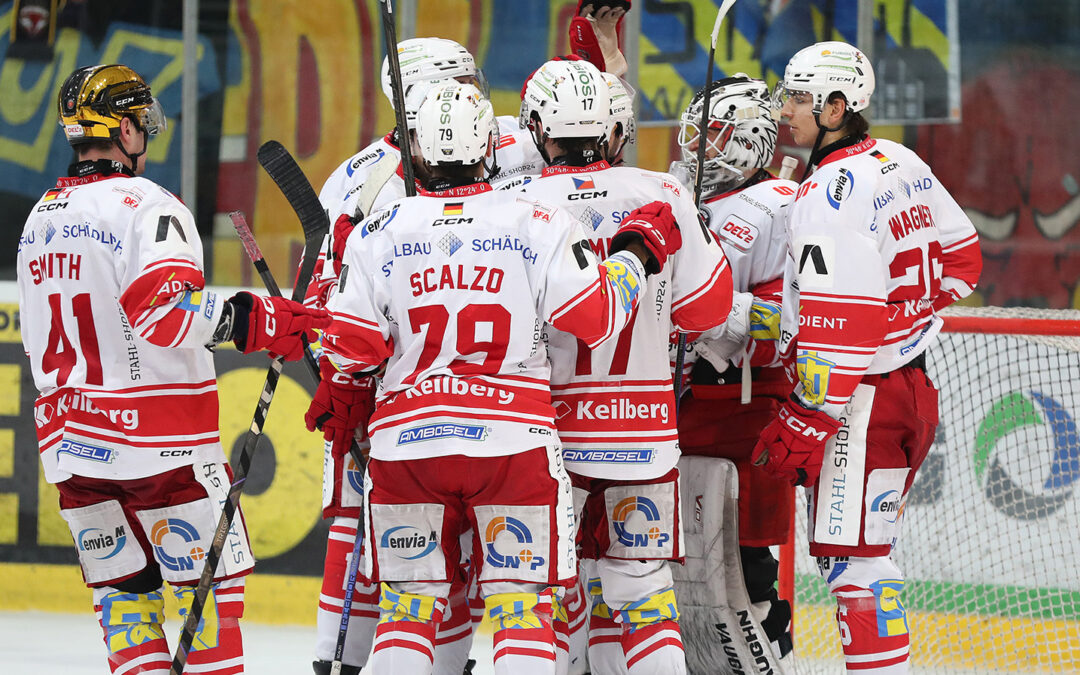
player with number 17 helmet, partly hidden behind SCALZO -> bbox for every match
[521,60,731,674]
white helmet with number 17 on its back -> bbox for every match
[518,60,611,140]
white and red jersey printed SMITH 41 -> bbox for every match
[18,174,226,483]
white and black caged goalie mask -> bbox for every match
[678,73,777,197]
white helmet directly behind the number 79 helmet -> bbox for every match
[382,38,487,124]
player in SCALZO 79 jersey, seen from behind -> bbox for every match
[323,83,680,674]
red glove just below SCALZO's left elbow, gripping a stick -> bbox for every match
[303,357,375,457]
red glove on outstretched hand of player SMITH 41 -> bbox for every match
[229,291,330,361]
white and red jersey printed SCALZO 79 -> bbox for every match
[323,184,645,460]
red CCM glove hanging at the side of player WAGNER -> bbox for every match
[751,394,840,486]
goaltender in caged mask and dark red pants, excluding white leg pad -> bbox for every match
[672,73,798,665]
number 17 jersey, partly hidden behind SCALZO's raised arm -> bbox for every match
[521,162,731,480]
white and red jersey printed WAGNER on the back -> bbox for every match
[782,138,982,416]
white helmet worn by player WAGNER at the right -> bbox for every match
[772,42,875,113]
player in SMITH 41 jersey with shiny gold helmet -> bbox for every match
[17,65,328,675]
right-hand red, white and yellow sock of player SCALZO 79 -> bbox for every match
[484,589,555,675]
